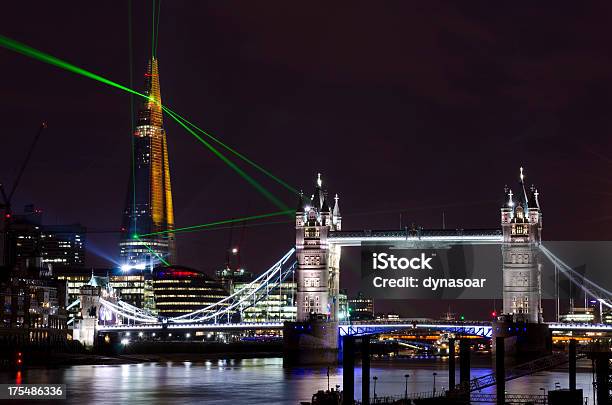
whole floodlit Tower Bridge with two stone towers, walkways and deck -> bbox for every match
[74,170,612,360]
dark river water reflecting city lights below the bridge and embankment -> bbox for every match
[0,358,593,405]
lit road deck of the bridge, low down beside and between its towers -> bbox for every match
[97,320,612,338]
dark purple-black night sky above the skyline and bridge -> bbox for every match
[0,1,612,318]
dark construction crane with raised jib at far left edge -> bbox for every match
[0,122,47,269]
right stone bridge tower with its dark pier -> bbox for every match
[493,167,552,358]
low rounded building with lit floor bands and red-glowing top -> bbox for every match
[153,266,230,318]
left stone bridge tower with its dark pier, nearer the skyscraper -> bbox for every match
[284,173,342,364]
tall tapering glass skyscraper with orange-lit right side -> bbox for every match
[119,58,176,269]
